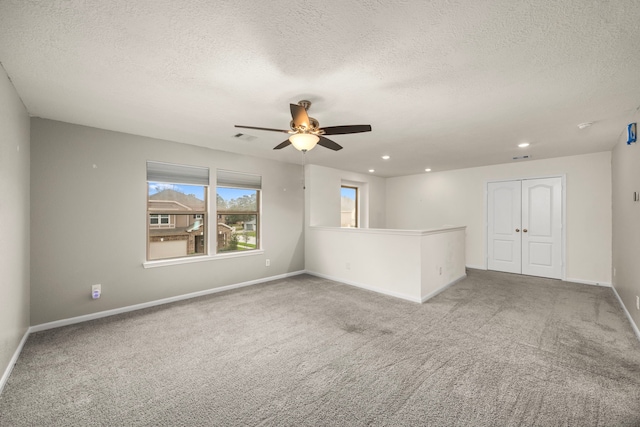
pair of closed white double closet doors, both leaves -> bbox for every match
[487,177,563,279]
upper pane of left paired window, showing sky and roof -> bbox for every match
[148,182,206,212]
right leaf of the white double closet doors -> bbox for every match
[521,178,562,279]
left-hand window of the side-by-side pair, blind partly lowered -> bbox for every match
[147,161,209,261]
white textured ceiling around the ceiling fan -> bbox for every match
[0,0,640,176]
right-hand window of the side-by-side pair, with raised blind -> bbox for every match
[216,170,262,253]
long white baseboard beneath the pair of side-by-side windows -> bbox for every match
[29,270,304,332]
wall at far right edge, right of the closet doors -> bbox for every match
[611,113,640,334]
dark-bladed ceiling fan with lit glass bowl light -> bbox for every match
[235,100,371,152]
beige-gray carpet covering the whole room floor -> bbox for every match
[0,270,640,427]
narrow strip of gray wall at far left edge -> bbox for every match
[0,66,29,386]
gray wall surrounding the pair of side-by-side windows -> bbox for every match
[31,118,304,325]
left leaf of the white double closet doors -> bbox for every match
[487,181,522,273]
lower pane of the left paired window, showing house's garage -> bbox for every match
[148,214,207,260]
